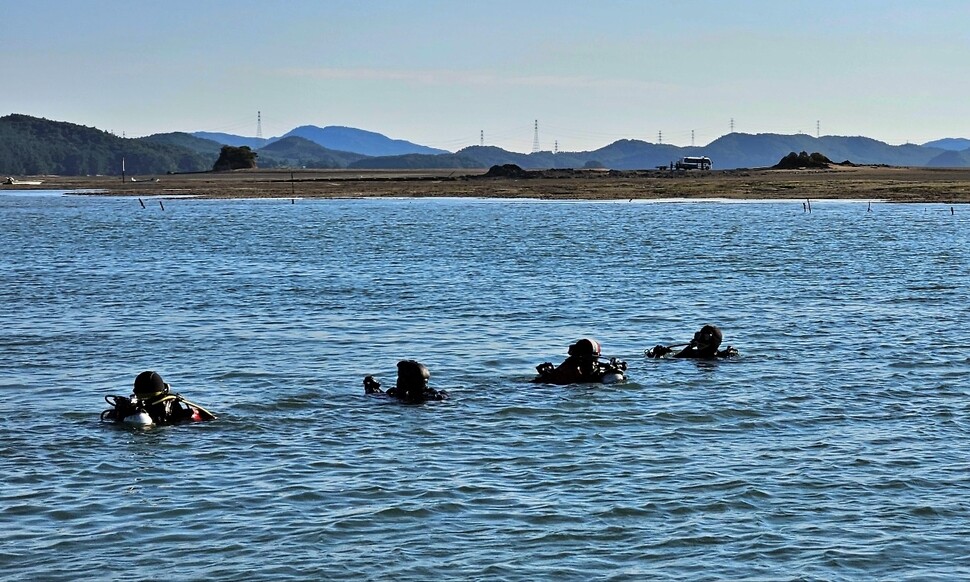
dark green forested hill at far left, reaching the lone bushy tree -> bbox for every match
[0,114,219,176]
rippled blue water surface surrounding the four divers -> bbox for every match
[0,192,970,580]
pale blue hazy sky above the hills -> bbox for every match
[0,0,970,152]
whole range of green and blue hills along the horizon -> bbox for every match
[0,114,970,176]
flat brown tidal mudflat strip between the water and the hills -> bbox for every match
[0,166,970,204]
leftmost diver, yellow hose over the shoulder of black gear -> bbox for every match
[101,370,216,424]
